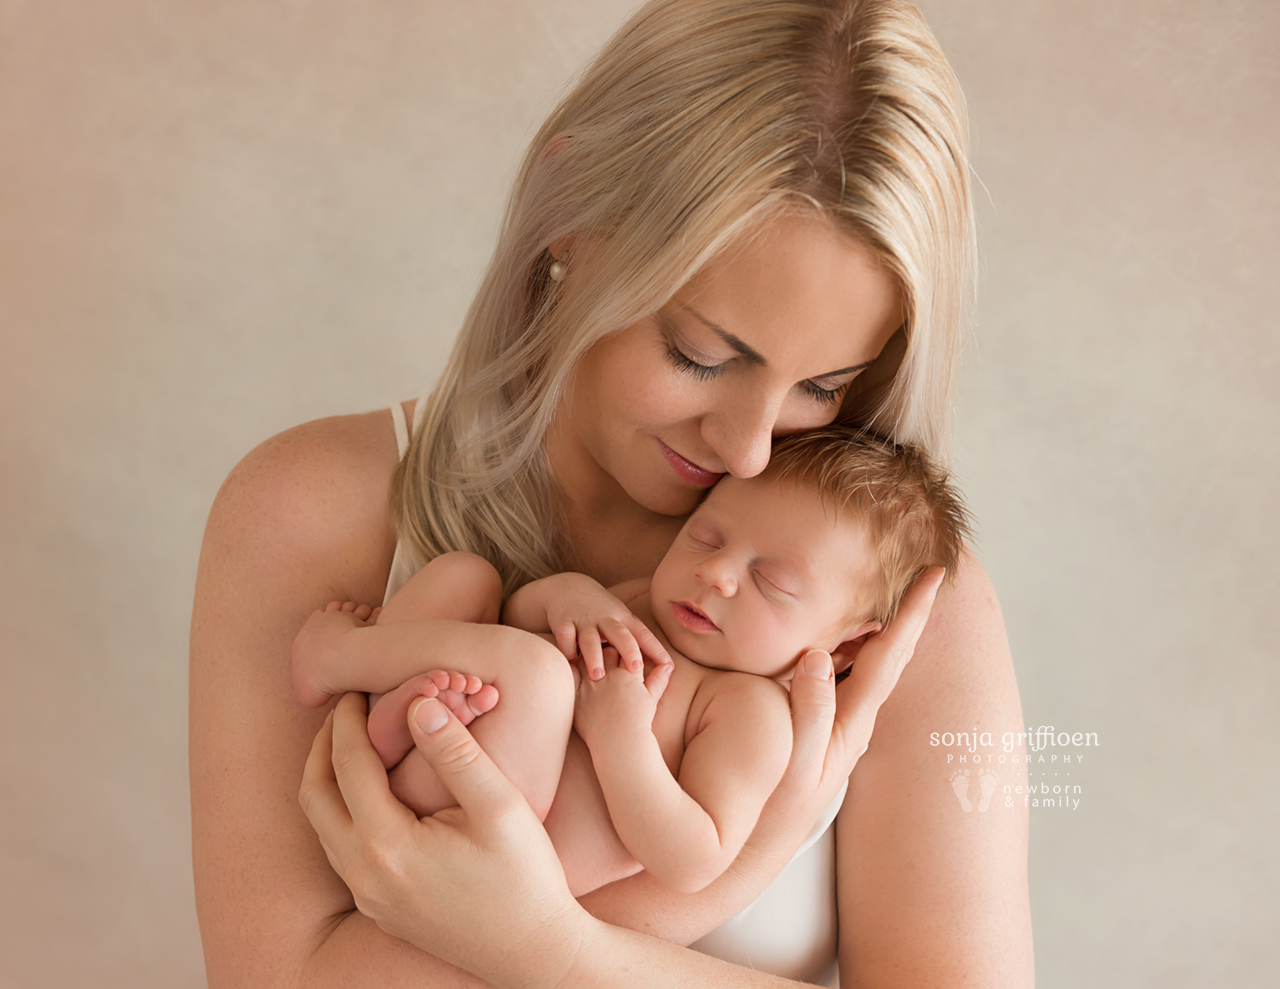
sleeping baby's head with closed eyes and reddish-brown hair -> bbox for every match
[652,426,969,677]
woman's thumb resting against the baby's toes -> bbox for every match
[408,697,527,823]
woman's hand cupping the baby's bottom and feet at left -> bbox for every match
[298,693,593,984]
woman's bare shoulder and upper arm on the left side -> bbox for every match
[189,412,504,988]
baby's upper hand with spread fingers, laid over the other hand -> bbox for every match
[547,573,671,681]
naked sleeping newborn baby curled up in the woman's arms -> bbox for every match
[293,426,968,896]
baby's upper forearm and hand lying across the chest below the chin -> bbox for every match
[502,573,671,679]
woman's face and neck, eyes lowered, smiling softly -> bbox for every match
[549,216,902,516]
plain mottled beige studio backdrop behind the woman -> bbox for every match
[0,0,1280,986]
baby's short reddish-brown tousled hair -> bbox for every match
[762,425,972,624]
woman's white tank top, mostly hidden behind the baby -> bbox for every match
[383,399,849,986]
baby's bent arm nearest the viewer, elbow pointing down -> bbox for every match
[573,667,791,893]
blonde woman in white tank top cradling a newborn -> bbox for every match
[191,0,1030,985]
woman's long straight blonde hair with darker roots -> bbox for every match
[390,0,973,592]
